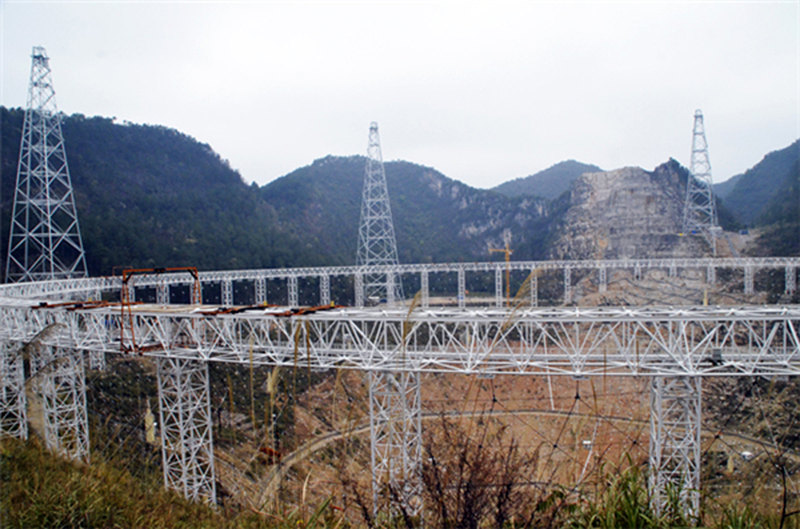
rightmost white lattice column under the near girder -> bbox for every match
[650,377,702,517]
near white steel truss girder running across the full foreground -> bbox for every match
[0,306,800,376]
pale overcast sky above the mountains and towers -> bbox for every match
[0,0,800,187]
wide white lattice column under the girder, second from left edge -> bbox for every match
[31,347,89,461]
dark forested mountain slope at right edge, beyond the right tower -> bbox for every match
[723,140,800,226]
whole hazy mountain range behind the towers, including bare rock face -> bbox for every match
[0,107,800,274]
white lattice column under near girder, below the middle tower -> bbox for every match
[369,371,422,516]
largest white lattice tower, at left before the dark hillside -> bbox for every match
[5,46,87,282]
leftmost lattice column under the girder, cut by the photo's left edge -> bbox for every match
[0,342,28,439]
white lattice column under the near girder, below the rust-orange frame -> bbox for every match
[156,358,216,503]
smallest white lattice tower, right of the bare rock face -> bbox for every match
[683,109,719,256]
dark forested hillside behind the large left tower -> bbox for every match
[0,107,318,275]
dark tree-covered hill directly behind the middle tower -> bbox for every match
[262,156,547,264]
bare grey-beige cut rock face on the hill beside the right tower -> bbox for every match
[549,160,704,259]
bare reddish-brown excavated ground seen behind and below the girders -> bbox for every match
[211,270,794,520]
